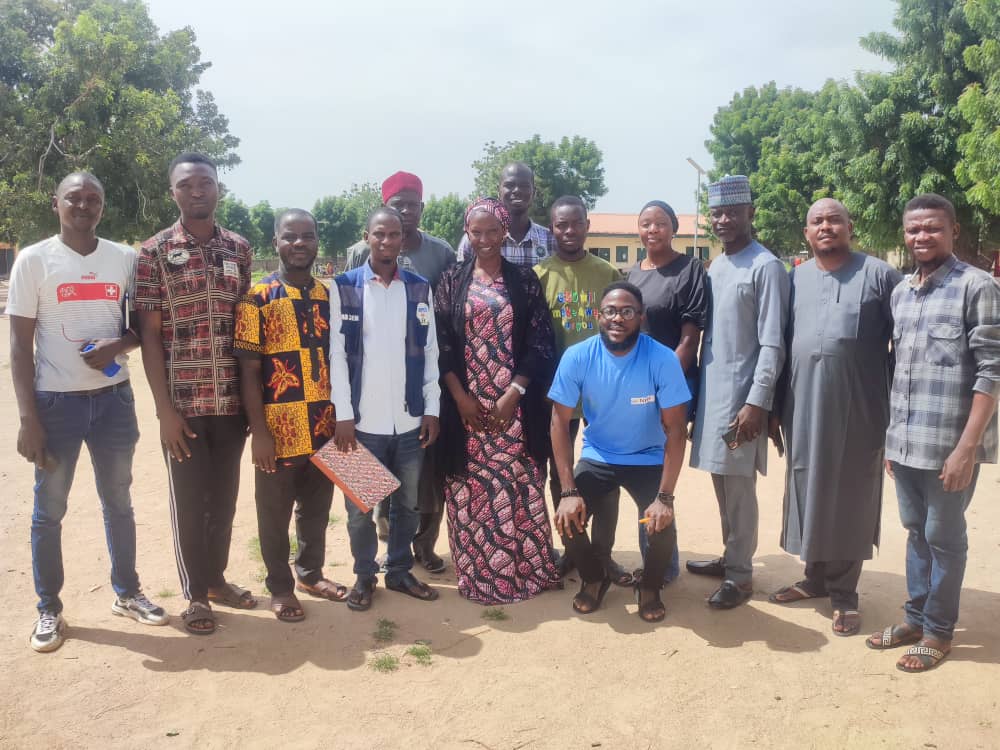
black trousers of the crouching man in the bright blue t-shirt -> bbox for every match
[562,459,677,588]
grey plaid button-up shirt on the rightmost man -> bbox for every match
[885,256,1000,469]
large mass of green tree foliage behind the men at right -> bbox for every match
[706,0,1000,259]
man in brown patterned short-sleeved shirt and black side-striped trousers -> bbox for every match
[135,153,257,635]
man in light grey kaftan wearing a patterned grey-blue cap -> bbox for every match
[687,175,788,609]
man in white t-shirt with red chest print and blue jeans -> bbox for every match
[7,172,169,651]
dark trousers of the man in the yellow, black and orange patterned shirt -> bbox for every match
[254,461,333,595]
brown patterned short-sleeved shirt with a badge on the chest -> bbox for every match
[135,221,250,417]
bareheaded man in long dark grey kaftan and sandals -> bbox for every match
[771,198,902,635]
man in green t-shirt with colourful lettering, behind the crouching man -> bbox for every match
[535,195,632,586]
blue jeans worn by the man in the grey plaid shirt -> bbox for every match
[892,461,979,641]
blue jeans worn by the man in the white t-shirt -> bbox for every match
[31,382,139,612]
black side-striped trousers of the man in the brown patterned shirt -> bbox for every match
[164,415,247,601]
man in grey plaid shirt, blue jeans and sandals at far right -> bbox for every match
[867,193,1000,672]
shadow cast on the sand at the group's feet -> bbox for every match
[69,551,1000,674]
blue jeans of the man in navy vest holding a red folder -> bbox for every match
[344,429,424,584]
